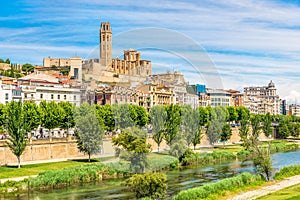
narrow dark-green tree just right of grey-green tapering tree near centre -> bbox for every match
[165,104,180,146]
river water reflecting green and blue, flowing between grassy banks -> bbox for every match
[4,151,300,200]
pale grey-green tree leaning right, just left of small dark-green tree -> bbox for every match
[206,106,226,145]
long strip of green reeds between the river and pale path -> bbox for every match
[173,172,264,200]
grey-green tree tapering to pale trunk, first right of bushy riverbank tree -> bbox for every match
[149,106,167,153]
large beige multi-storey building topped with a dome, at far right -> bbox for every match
[244,81,281,115]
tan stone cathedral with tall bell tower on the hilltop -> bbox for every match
[82,22,152,83]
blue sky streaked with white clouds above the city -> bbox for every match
[0,0,300,104]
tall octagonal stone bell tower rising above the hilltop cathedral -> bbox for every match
[100,22,112,66]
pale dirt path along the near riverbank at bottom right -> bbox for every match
[230,175,300,200]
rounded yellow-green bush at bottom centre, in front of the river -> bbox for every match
[126,173,168,199]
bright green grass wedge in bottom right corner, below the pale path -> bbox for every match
[258,184,300,200]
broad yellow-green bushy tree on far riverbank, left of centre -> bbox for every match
[112,127,151,173]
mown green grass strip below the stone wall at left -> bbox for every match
[0,157,113,179]
